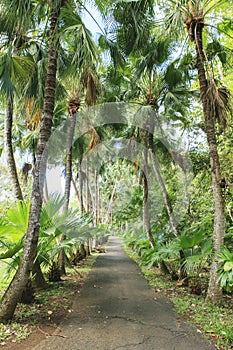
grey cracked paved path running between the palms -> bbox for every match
[34,237,214,350]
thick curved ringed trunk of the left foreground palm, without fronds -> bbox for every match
[0,0,61,322]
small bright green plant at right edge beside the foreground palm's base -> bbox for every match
[217,246,233,292]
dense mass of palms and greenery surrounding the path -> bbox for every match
[0,0,233,341]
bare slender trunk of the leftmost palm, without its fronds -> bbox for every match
[4,96,23,201]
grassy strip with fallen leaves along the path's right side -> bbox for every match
[126,248,233,350]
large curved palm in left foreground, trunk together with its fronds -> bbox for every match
[0,0,104,321]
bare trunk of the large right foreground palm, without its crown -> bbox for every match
[196,22,225,303]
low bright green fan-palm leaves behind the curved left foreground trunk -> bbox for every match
[0,194,91,287]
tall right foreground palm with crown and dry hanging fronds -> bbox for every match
[162,0,229,303]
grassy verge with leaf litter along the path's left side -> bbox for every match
[0,254,98,349]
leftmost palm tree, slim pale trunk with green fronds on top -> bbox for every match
[0,0,33,201]
